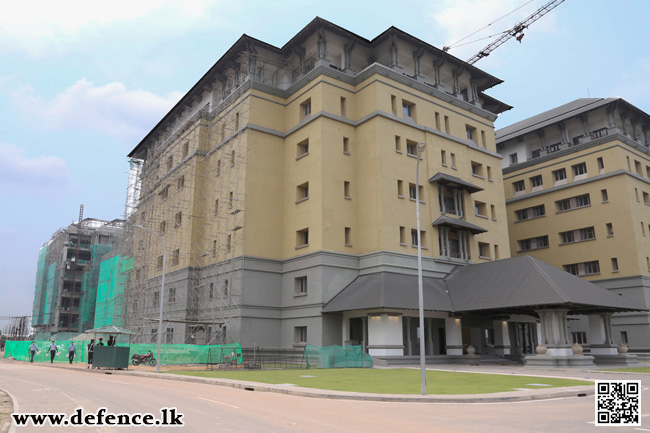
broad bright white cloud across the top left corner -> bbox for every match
[0,0,229,55]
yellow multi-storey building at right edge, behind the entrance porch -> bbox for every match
[496,98,650,351]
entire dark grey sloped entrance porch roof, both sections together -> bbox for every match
[323,256,648,314]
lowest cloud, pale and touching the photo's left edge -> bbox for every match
[0,142,70,194]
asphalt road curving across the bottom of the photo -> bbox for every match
[0,360,650,433]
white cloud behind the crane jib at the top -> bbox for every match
[429,0,555,60]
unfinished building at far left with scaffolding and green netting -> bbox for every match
[32,218,124,338]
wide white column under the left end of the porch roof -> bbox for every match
[368,313,404,356]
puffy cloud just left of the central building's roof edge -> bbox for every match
[14,78,183,141]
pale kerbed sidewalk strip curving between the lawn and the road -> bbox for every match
[1,359,612,403]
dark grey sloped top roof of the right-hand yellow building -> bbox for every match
[496,98,620,143]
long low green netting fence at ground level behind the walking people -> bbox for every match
[4,340,242,365]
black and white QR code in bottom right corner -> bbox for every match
[596,380,641,426]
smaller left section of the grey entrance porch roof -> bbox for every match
[323,272,452,313]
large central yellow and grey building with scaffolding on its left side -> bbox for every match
[127,18,636,362]
